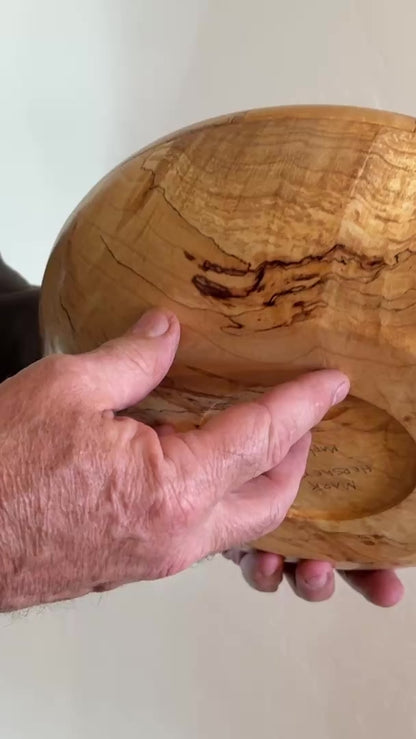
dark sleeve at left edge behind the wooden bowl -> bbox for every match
[0,255,41,382]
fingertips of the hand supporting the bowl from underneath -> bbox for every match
[224,548,404,608]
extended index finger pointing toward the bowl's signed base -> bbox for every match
[174,370,349,492]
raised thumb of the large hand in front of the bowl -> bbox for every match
[82,310,180,411]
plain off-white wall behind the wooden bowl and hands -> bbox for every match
[0,0,416,739]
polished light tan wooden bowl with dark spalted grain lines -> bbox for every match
[41,107,416,568]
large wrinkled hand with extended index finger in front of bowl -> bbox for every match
[0,311,348,611]
